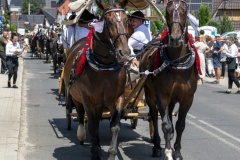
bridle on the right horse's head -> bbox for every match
[167,0,187,46]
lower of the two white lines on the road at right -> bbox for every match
[187,120,240,152]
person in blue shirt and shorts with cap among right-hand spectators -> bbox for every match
[212,34,222,84]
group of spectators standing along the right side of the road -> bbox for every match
[194,31,240,94]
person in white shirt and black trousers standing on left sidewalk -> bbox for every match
[6,33,23,88]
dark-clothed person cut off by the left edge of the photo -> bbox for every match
[0,31,8,74]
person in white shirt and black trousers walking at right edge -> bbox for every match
[223,38,240,94]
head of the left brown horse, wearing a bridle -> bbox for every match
[93,0,133,62]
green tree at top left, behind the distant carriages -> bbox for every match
[21,0,44,14]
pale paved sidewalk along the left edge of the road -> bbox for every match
[0,58,23,160]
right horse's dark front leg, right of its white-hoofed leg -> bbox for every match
[174,102,192,160]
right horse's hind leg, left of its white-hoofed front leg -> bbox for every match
[144,87,162,157]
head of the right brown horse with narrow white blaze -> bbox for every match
[166,0,188,46]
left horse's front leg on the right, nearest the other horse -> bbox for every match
[108,95,124,160]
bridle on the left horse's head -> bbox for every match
[94,8,129,60]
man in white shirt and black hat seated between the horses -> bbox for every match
[128,11,152,67]
